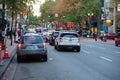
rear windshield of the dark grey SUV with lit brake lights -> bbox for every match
[24,36,43,44]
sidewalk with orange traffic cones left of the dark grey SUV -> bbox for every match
[0,39,16,79]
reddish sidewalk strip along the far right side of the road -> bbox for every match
[80,37,115,45]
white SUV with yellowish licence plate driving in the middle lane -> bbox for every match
[54,31,81,52]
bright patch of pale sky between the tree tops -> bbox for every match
[33,0,45,16]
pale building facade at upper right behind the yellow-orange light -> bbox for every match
[104,0,120,33]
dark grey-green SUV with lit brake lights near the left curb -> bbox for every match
[16,33,47,62]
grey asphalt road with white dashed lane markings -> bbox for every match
[1,42,120,80]
